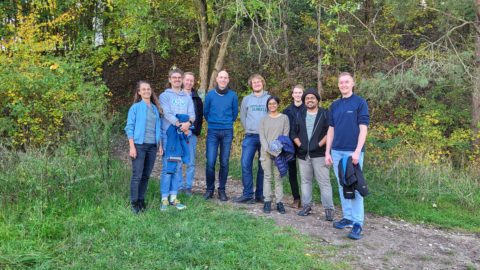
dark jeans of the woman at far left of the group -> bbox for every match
[130,143,157,202]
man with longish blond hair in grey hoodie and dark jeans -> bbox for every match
[235,74,270,203]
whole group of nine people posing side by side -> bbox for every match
[125,69,369,240]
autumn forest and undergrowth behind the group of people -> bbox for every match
[0,0,480,266]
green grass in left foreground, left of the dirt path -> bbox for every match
[0,149,347,269]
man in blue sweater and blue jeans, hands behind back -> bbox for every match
[203,70,238,201]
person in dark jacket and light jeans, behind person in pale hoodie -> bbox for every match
[179,72,203,195]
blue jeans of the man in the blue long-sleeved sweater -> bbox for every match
[205,129,233,191]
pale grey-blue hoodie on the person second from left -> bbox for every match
[160,88,195,135]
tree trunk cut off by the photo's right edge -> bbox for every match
[472,0,480,146]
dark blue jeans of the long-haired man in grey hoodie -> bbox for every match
[241,134,263,198]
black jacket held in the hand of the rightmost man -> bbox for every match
[338,156,368,199]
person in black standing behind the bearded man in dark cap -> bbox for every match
[283,84,306,208]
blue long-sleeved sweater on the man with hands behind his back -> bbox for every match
[203,89,238,129]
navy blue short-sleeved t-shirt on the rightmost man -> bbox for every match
[329,94,370,152]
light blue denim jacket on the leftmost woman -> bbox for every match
[125,100,162,145]
